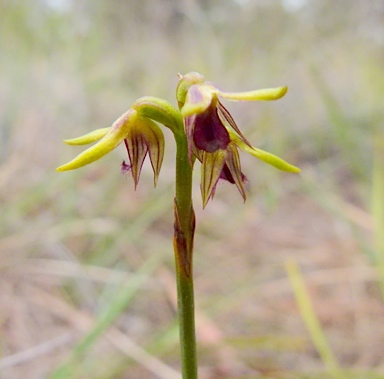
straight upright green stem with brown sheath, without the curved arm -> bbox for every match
[173,129,197,379]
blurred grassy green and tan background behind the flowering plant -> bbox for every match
[0,0,384,379]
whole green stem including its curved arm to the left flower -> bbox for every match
[132,96,197,379]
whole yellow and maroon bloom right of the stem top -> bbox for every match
[176,72,300,207]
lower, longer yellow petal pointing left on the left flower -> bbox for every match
[56,110,137,171]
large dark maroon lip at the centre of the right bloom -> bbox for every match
[193,106,230,153]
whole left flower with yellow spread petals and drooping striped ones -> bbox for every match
[56,109,164,188]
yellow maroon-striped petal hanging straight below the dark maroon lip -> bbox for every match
[201,149,227,208]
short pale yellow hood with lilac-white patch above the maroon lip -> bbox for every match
[181,84,213,117]
